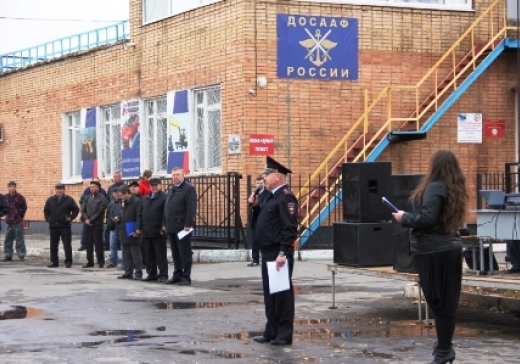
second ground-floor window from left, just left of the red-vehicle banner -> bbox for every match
[100,104,123,178]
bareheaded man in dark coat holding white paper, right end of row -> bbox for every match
[164,167,197,285]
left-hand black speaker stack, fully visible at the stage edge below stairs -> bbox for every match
[333,162,393,267]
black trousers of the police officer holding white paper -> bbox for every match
[262,250,294,343]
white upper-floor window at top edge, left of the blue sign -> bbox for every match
[143,0,223,24]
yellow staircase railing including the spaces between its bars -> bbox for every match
[298,0,515,245]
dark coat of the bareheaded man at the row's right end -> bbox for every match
[163,181,197,234]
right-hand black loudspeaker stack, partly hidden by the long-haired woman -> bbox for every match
[390,174,424,273]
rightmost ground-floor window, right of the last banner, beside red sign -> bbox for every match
[192,86,222,173]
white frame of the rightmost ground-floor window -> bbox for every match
[190,85,223,174]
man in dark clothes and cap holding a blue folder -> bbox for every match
[117,186,143,280]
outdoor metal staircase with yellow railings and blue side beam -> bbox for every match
[297,0,518,247]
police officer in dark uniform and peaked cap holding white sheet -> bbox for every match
[253,156,298,346]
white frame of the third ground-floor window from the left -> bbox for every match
[139,95,168,176]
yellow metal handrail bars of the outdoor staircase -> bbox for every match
[297,0,513,233]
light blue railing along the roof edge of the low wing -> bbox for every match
[0,20,130,73]
